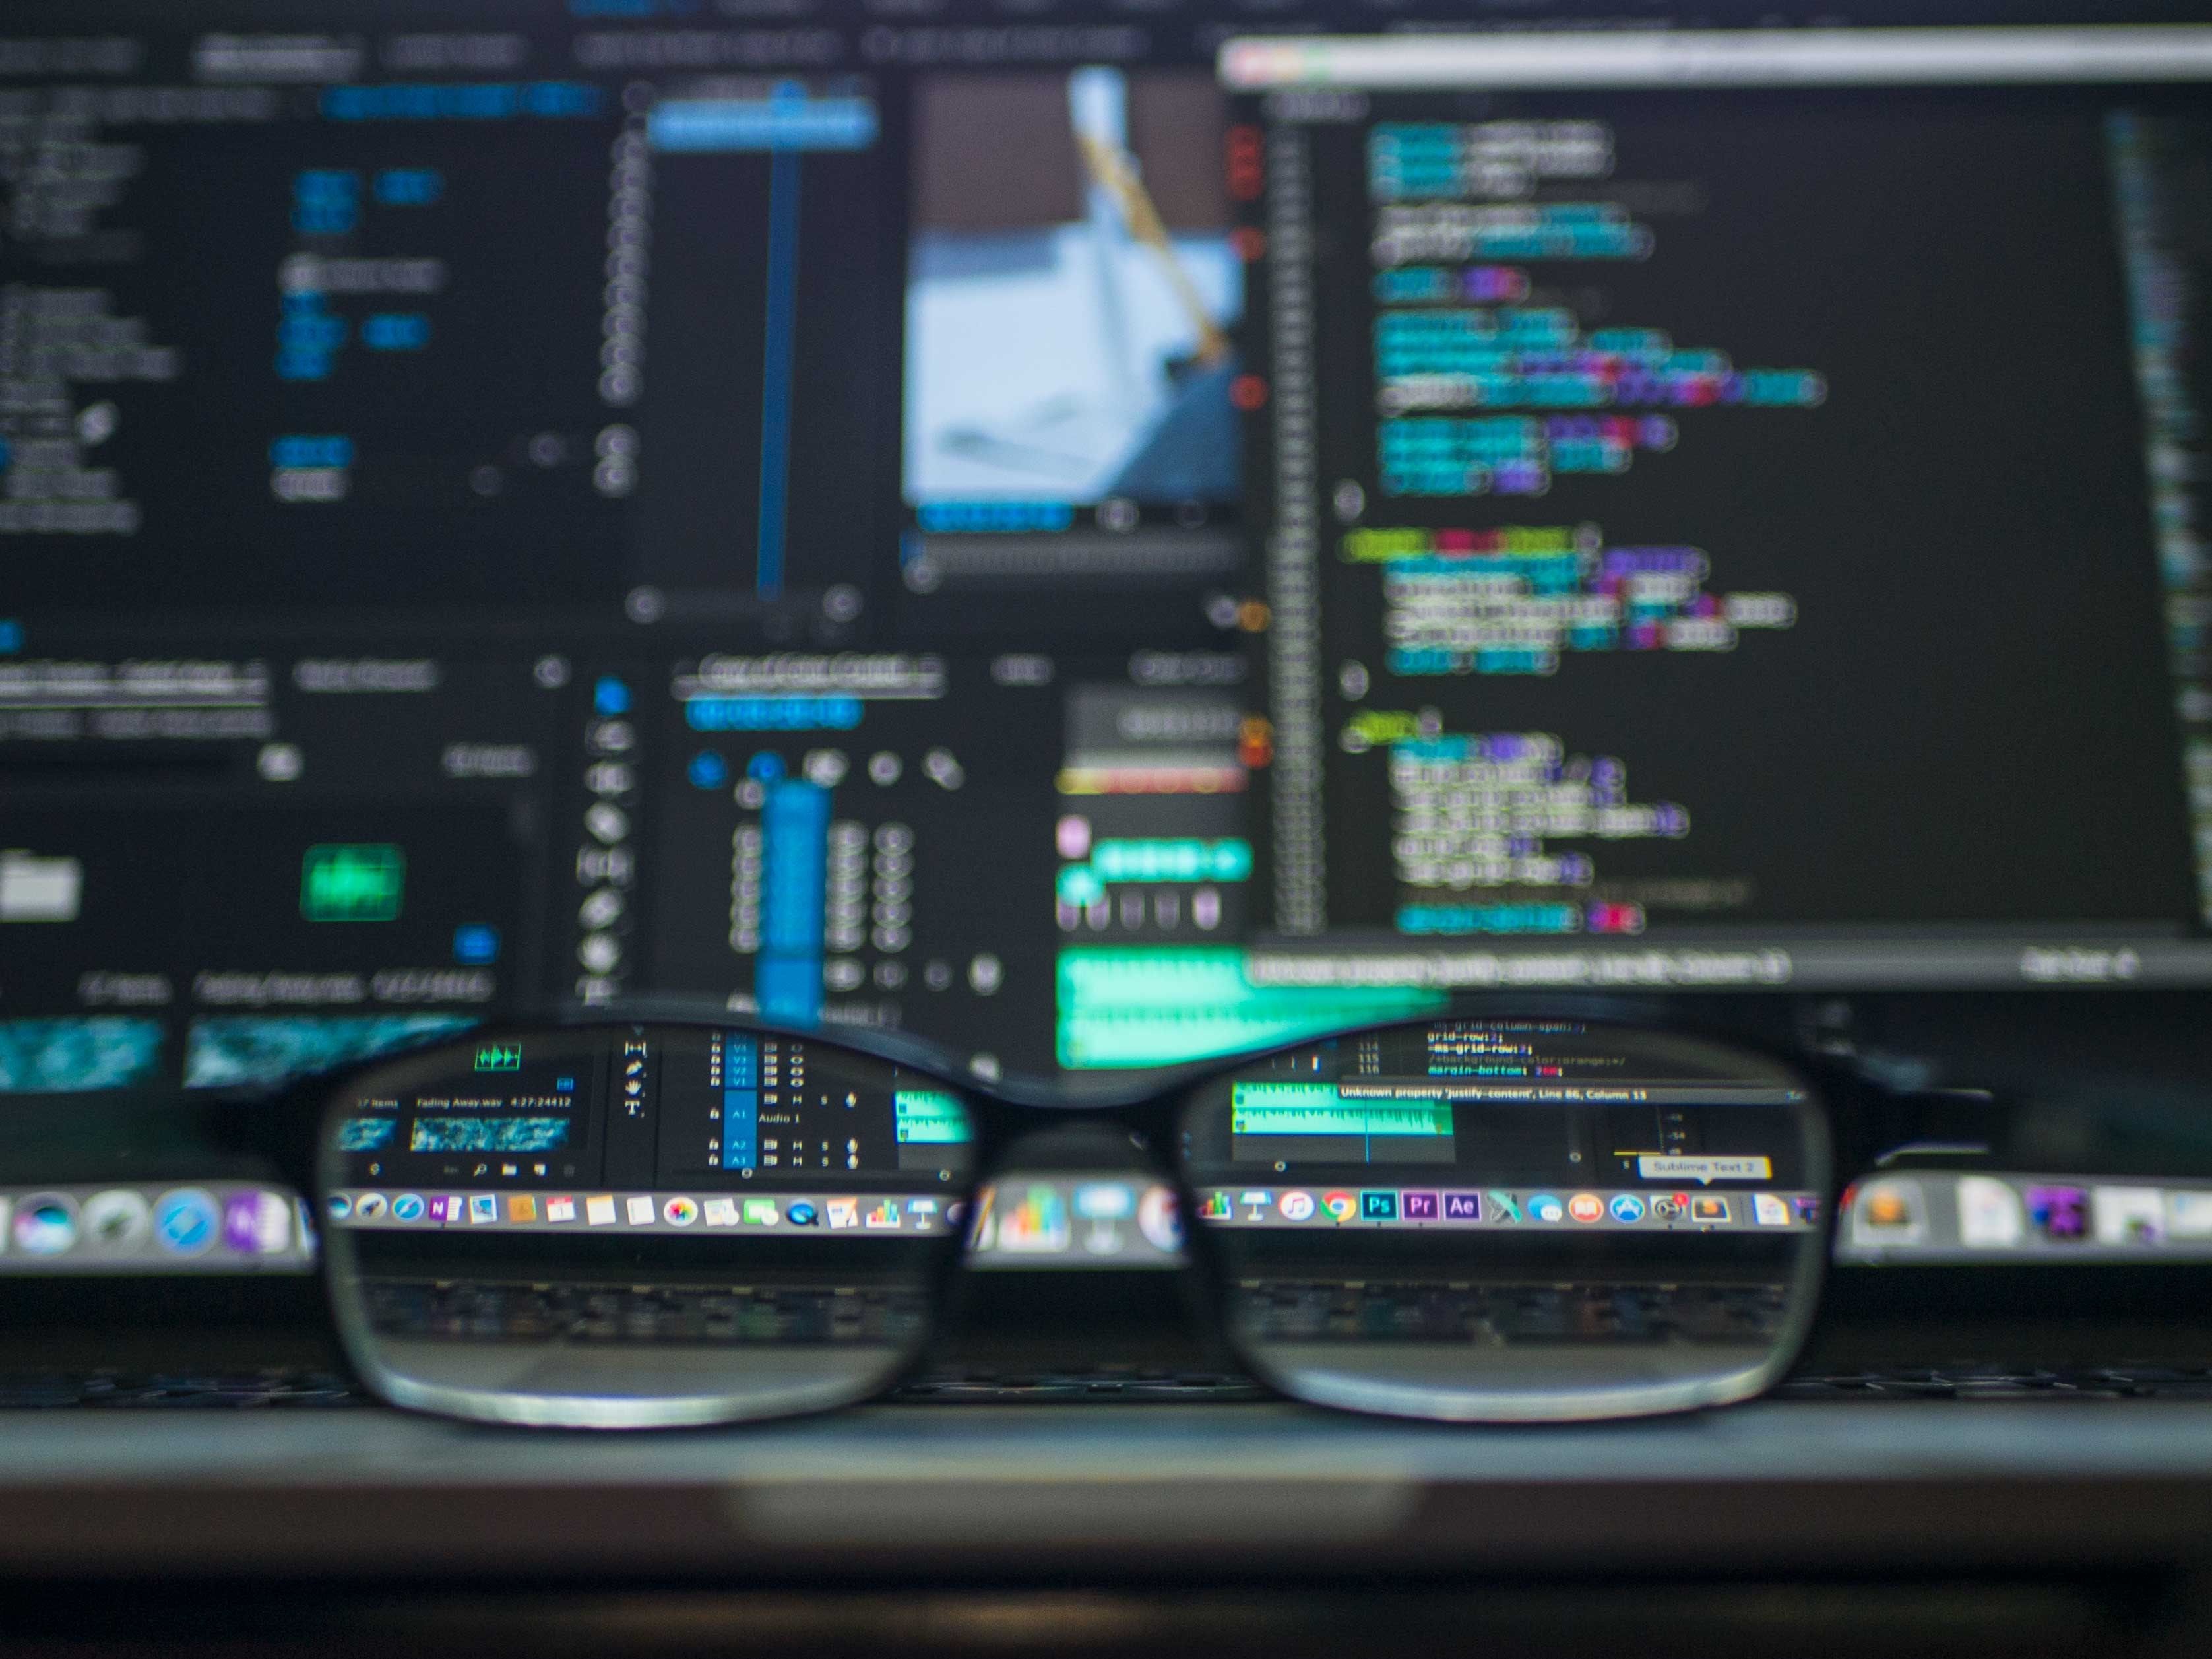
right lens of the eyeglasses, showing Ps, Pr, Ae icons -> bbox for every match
[1182,1020,1827,1420]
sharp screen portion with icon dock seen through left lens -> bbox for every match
[330,1026,971,1234]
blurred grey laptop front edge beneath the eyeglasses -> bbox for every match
[0,1402,2212,1584]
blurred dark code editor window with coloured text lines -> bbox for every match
[1223,31,2212,989]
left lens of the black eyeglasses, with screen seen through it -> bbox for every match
[321,1026,971,1427]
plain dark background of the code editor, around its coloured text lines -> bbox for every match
[1311,90,2192,927]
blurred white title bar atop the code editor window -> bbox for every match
[1219,24,2212,93]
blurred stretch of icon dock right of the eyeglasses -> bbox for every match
[1836,1170,2212,1268]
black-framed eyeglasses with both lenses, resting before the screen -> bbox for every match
[242,1018,1831,1429]
